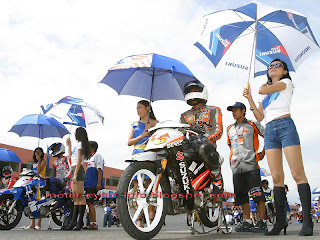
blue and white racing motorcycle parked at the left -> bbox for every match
[0,169,72,230]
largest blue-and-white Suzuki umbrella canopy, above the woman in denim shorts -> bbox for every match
[195,2,319,77]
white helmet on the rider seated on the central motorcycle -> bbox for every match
[183,80,208,106]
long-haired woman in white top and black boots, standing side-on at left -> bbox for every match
[66,127,91,230]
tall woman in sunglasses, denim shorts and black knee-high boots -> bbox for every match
[243,59,313,236]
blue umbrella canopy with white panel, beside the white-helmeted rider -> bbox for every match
[100,53,196,102]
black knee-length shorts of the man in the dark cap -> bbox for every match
[233,169,265,206]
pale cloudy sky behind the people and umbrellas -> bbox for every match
[0,0,320,203]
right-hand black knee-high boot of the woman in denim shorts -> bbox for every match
[298,183,313,236]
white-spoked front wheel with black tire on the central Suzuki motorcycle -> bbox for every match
[117,162,169,239]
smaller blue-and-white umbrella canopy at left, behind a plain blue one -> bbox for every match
[41,96,104,127]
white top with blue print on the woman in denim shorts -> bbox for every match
[259,78,293,124]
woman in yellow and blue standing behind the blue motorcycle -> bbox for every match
[24,147,47,230]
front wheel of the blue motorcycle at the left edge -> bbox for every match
[0,195,22,230]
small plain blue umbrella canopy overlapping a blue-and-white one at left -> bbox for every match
[9,114,69,139]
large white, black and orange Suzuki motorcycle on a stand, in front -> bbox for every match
[117,121,230,239]
